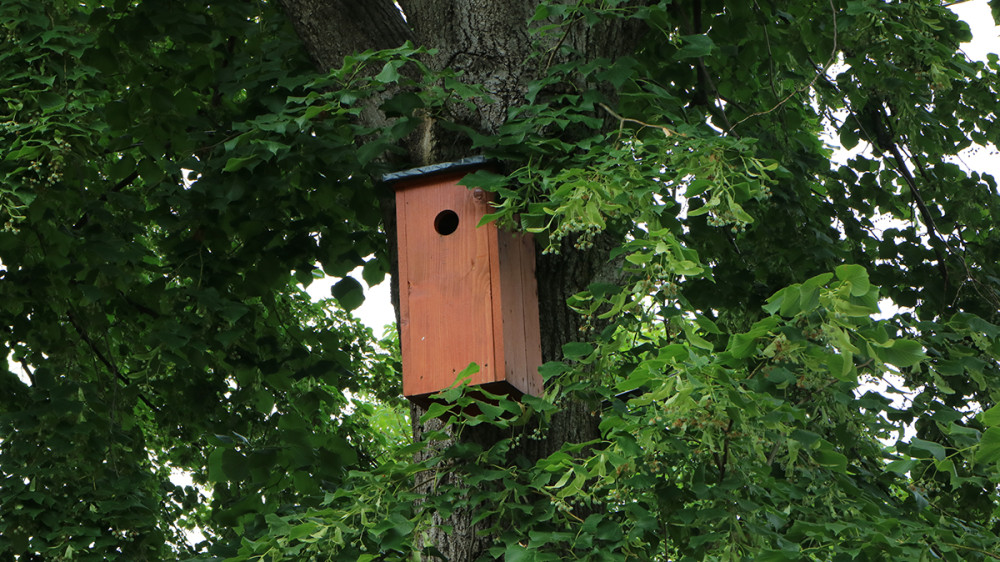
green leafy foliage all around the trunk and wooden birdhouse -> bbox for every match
[0,0,1000,561]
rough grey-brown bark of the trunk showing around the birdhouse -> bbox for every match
[280,0,637,561]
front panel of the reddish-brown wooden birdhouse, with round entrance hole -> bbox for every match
[396,174,503,396]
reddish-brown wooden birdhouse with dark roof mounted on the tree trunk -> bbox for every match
[384,158,542,402]
